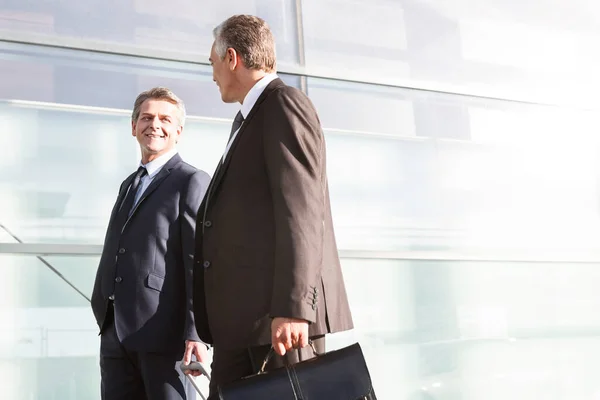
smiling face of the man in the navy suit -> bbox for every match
[131,99,183,164]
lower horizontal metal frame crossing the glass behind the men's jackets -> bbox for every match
[0,243,600,264]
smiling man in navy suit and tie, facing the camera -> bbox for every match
[92,88,210,400]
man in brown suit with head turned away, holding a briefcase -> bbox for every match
[194,15,353,399]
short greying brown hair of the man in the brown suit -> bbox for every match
[213,15,276,72]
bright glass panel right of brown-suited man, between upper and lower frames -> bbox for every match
[308,78,600,256]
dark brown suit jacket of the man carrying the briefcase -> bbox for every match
[194,79,352,348]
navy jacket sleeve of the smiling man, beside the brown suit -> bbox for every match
[180,170,210,341]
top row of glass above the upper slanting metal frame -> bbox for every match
[0,0,600,105]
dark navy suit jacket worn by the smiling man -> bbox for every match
[92,154,210,352]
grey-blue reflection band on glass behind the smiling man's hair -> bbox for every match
[0,42,236,118]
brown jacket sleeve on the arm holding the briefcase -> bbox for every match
[263,88,325,322]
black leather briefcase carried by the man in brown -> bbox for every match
[219,343,377,400]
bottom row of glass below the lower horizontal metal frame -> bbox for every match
[0,255,600,400]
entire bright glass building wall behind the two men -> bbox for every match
[0,0,600,400]
